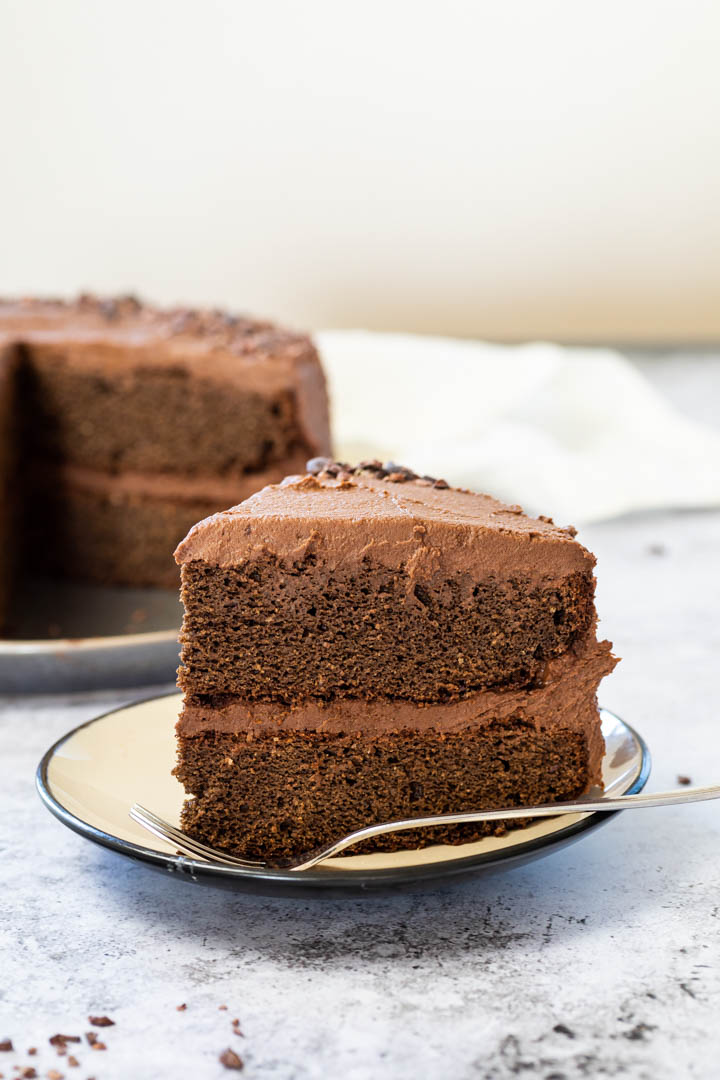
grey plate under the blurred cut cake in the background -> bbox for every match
[0,579,182,693]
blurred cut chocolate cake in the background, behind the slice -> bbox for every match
[0,297,329,618]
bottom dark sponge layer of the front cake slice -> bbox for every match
[175,718,588,859]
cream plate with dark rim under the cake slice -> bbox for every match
[37,693,650,896]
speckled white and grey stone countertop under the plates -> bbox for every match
[0,360,720,1080]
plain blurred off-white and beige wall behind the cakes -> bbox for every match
[0,0,720,341]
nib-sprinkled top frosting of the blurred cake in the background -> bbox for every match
[0,295,330,453]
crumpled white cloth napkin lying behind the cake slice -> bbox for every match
[316,330,720,524]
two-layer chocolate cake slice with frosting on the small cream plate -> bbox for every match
[171,459,615,856]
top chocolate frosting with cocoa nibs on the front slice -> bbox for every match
[175,460,595,581]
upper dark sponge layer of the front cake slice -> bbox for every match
[178,559,594,703]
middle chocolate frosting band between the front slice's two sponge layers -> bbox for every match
[177,633,617,782]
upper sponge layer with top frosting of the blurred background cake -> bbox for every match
[0,298,329,472]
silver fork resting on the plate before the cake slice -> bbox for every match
[130,784,720,873]
